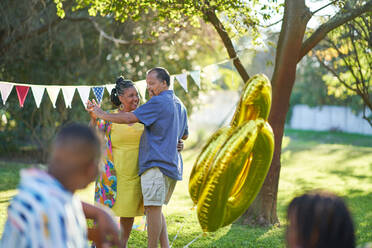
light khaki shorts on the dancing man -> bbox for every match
[141,167,177,206]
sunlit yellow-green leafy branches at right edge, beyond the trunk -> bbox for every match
[315,13,372,125]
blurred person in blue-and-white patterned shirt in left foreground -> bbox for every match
[0,124,120,248]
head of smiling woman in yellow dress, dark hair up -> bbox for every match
[111,77,139,112]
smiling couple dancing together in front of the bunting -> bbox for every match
[87,67,188,247]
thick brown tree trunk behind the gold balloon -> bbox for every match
[238,0,311,226]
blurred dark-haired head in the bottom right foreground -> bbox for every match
[287,191,355,248]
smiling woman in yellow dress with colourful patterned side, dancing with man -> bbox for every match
[87,77,144,247]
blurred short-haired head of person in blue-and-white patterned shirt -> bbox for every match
[48,124,101,192]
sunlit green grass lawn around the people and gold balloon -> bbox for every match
[0,130,372,248]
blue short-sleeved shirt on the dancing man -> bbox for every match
[133,90,188,180]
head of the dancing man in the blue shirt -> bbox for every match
[146,67,170,97]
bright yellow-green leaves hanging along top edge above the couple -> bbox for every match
[54,0,280,44]
